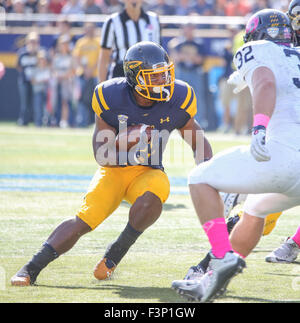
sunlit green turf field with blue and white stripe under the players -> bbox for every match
[0,123,300,303]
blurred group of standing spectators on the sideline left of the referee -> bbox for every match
[17,20,100,128]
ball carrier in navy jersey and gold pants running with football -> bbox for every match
[11,42,212,286]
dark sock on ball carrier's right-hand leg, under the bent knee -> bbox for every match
[104,222,142,265]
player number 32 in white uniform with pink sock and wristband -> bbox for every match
[172,9,300,302]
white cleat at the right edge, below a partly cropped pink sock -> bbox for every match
[265,238,300,264]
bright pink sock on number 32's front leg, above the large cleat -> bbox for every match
[203,217,233,258]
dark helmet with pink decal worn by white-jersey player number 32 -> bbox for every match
[244,9,292,44]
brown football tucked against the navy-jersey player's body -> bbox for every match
[116,124,151,151]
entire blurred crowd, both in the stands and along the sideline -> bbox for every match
[0,0,289,134]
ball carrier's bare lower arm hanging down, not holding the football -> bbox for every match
[179,118,213,165]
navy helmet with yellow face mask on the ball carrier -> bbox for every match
[123,41,175,101]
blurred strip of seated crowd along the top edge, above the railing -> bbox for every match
[0,0,288,16]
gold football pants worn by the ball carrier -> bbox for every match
[77,166,170,230]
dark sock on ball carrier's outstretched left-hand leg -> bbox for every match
[17,242,58,284]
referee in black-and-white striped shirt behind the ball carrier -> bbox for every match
[98,0,161,82]
